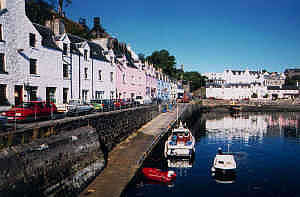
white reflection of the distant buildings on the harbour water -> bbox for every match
[205,112,300,144]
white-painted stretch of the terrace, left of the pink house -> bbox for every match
[0,0,116,110]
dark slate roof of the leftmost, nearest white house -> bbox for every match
[33,23,61,51]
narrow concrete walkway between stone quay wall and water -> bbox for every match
[80,107,181,197]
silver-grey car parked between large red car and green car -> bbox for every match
[66,99,94,116]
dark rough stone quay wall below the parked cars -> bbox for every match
[0,105,159,196]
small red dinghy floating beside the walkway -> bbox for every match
[142,168,176,183]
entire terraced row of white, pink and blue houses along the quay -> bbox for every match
[0,0,183,109]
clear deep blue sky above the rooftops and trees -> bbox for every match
[65,0,300,73]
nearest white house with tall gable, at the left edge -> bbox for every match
[0,0,64,106]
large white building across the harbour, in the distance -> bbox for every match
[204,69,285,99]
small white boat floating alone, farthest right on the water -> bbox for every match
[211,145,236,174]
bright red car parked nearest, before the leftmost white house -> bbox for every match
[3,101,57,122]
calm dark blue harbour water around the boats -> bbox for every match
[123,113,300,197]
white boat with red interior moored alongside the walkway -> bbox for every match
[164,122,195,158]
